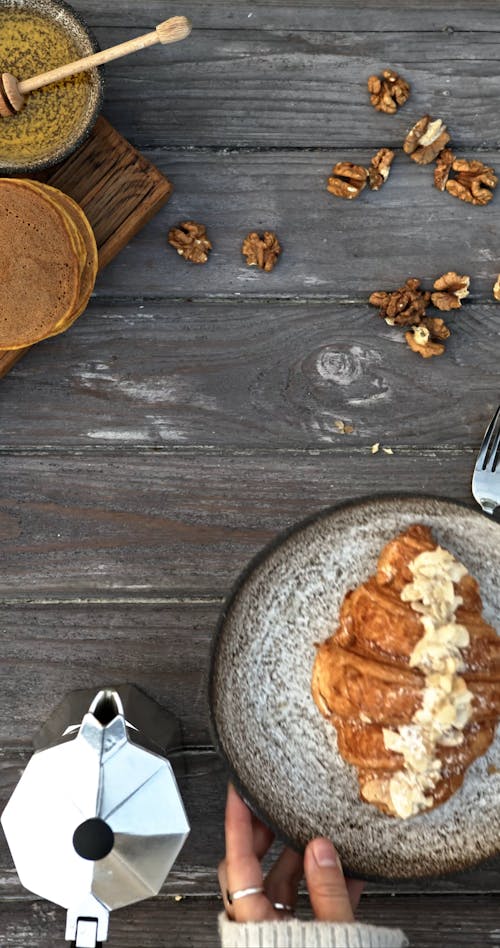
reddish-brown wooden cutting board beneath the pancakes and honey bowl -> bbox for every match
[0,117,172,378]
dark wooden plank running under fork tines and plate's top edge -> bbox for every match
[0,445,480,601]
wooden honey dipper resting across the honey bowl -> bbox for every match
[0,16,191,118]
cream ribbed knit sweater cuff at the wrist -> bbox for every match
[219,912,409,948]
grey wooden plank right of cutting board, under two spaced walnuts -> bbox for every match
[69,150,500,302]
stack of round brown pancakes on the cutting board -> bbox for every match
[0,178,98,350]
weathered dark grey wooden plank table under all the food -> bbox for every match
[0,0,500,948]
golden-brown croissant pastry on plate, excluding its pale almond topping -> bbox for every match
[312,524,500,815]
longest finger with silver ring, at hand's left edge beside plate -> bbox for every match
[225,784,278,922]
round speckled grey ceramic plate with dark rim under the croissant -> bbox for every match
[210,496,500,878]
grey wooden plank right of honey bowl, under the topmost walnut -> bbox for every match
[63,22,500,150]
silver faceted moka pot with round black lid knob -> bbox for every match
[2,685,189,948]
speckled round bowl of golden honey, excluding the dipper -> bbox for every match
[0,0,103,175]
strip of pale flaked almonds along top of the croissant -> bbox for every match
[383,546,473,819]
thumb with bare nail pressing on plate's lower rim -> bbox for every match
[304,838,354,922]
